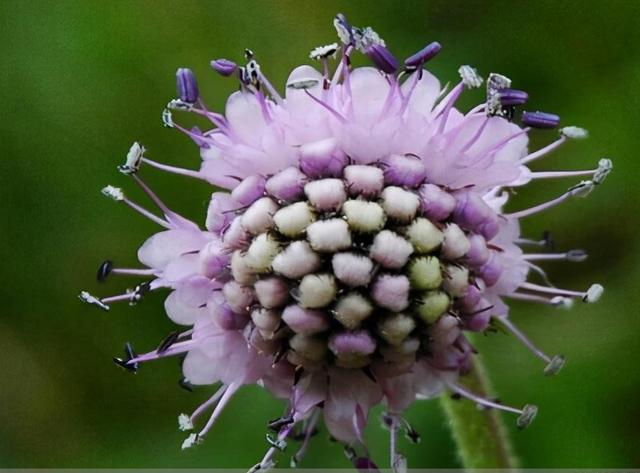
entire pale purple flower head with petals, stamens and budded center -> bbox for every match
[80,15,611,468]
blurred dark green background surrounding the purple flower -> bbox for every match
[0,0,640,468]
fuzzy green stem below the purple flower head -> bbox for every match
[441,356,518,469]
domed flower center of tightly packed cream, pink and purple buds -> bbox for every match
[218,150,499,370]
